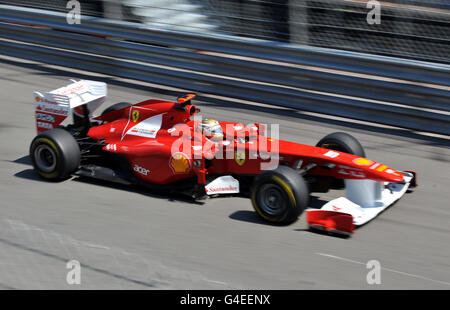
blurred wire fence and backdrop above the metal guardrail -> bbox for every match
[0,0,450,63]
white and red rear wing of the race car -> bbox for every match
[34,80,107,133]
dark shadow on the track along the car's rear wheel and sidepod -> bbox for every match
[12,155,205,205]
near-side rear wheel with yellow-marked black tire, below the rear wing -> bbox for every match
[30,128,81,180]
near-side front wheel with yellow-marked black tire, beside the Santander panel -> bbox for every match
[251,166,309,224]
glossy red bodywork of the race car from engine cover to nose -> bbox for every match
[88,98,403,184]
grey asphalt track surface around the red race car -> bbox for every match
[0,56,450,289]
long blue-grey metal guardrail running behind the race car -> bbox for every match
[0,5,450,135]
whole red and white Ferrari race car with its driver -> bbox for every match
[30,80,416,234]
